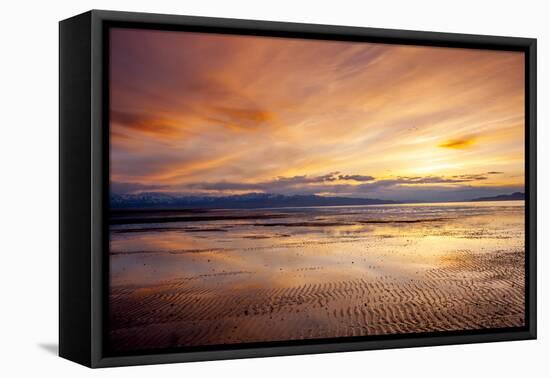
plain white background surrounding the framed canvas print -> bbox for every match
[0,0,550,378]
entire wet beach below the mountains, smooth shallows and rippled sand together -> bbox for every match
[109,201,525,352]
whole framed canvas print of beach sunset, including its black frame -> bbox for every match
[59,11,536,367]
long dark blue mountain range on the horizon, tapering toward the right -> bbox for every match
[111,193,398,209]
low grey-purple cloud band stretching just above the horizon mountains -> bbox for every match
[114,172,523,201]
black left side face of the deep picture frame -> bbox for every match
[59,12,93,366]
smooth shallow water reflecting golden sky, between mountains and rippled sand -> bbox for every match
[111,201,524,286]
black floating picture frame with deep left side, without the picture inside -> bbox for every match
[59,10,537,367]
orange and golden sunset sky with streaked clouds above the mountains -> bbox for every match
[110,28,524,201]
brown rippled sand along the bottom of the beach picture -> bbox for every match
[110,250,525,351]
